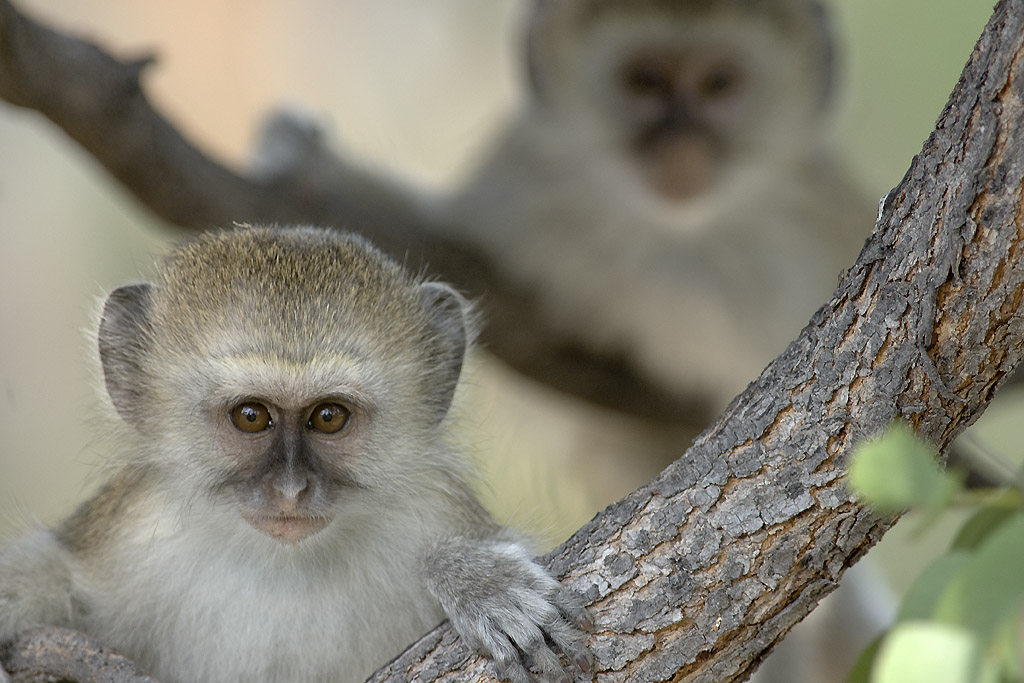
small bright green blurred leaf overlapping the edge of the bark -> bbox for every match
[850,422,963,512]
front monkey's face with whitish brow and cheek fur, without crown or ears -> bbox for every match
[140,324,415,544]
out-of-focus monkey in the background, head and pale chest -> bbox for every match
[440,0,874,415]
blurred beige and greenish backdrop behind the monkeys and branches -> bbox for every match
[0,0,1007,585]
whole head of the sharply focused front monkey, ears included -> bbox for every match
[99,228,466,544]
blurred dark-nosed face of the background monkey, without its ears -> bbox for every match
[594,19,819,202]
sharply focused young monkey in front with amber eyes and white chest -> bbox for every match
[0,227,593,683]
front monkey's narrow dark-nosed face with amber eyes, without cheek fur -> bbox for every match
[200,358,378,544]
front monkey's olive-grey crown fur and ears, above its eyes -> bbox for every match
[98,226,468,483]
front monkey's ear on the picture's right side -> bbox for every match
[420,283,469,413]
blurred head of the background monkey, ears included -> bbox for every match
[530,0,831,203]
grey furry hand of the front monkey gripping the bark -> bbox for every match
[427,538,594,683]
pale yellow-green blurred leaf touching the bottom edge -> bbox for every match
[871,622,998,683]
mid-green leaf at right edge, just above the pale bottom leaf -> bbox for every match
[934,511,1024,645]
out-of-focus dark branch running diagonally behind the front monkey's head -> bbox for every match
[0,0,713,429]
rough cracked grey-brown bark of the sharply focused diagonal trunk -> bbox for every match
[0,0,1024,683]
